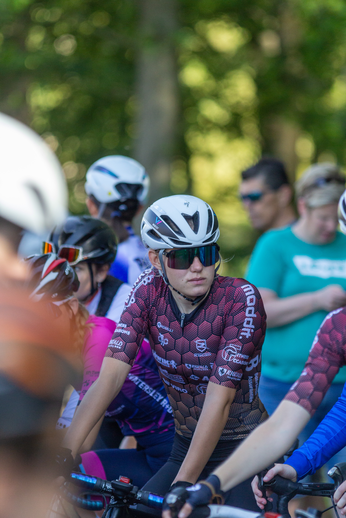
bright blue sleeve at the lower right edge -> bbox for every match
[285,385,346,480]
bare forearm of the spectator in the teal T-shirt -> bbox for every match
[260,290,318,328]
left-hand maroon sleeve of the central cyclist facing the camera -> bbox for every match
[105,271,151,367]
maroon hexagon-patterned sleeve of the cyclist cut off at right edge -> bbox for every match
[284,307,346,415]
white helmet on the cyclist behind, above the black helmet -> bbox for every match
[84,155,149,204]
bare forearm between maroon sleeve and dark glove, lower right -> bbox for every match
[214,401,310,491]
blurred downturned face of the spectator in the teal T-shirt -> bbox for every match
[298,199,339,245]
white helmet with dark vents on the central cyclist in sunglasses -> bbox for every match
[141,194,220,250]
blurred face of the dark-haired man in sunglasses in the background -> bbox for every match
[239,176,281,232]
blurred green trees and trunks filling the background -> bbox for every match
[0,0,346,275]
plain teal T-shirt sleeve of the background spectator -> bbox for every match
[246,231,284,294]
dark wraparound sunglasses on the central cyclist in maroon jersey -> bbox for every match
[163,244,220,270]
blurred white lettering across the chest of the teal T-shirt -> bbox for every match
[293,255,346,279]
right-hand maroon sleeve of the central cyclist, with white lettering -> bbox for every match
[210,281,266,388]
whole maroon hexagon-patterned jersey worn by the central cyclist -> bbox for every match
[106,269,267,439]
